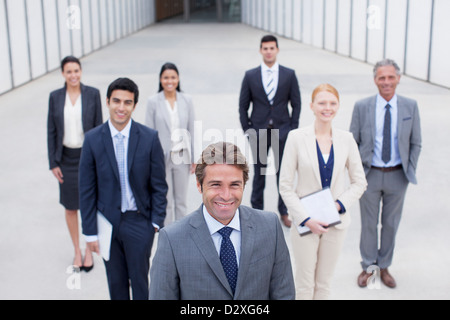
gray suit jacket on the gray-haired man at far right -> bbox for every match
[350,95,422,184]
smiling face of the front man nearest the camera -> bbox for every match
[197,164,244,225]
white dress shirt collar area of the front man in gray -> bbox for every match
[203,205,241,266]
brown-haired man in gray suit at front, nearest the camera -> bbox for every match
[150,142,295,300]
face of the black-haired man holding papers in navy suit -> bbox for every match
[106,90,136,131]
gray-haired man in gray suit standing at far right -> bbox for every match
[350,59,422,288]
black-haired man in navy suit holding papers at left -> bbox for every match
[79,78,167,300]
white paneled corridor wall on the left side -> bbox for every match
[0,0,155,94]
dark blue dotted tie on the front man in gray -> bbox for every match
[219,227,238,294]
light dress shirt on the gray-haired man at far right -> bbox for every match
[372,94,402,168]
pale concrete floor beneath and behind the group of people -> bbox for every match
[0,24,450,300]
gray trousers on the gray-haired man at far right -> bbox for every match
[360,169,409,270]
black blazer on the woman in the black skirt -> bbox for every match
[47,84,103,169]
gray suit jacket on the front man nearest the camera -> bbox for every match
[150,206,295,300]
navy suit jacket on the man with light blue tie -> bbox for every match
[79,121,167,236]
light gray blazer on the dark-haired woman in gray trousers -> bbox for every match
[145,91,195,163]
